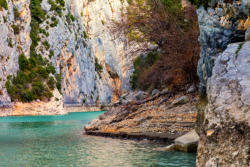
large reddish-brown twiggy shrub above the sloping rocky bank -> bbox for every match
[113,0,200,90]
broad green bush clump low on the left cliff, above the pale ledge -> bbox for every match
[5,53,61,102]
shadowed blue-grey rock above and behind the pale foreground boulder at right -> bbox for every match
[197,0,250,95]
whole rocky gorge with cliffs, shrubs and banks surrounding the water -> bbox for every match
[0,0,250,167]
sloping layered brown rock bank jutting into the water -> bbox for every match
[84,91,197,144]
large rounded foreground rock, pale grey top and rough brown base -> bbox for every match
[197,42,250,167]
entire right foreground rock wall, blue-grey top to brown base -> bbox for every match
[197,0,250,167]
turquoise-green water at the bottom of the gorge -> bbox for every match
[0,112,195,167]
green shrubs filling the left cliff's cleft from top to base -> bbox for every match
[5,0,63,102]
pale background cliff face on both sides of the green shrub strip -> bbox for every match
[0,0,133,115]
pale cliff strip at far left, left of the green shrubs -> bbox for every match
[0,0,31,106]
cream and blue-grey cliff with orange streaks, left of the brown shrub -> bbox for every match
[60,0,133,104]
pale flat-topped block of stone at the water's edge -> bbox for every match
[174,130,199,152]
